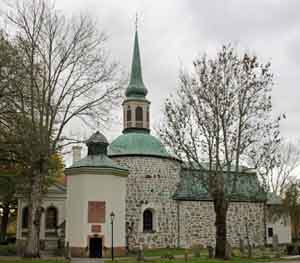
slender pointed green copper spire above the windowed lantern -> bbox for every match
[125,30,148,98]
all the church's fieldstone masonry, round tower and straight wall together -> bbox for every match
[113,156,264,249]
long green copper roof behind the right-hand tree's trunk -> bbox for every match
[173,169,266,202]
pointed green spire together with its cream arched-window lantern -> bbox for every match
[123,20,150,133]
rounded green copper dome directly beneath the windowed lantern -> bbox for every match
[108,132,171,157]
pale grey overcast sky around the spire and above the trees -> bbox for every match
[2,0,300,157]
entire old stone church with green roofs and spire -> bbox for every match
[17,27,291,257]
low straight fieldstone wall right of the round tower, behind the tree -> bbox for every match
[179,201,264,247]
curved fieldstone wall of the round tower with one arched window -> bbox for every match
[113,156,180,249]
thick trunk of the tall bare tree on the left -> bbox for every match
[24,176,42,258]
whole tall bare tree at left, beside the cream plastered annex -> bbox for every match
[1,0,121,257]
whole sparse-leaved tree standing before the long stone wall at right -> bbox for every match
[160,46,279,258]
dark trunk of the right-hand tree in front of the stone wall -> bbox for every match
[214,197,228,259]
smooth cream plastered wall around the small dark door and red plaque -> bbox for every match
[66,174,127,251]
